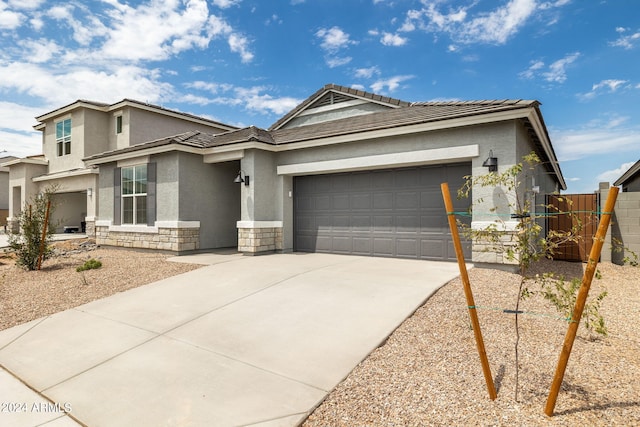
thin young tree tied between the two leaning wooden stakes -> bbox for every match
[458,153,607,401]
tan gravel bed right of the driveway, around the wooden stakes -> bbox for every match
[304,262,640,427]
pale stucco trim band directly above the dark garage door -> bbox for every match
[277,144,480,175]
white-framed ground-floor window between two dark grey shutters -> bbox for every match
[122,165,147,224]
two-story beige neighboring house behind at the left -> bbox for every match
[2,99,236,235]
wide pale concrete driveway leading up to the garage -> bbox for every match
[0,253,458,427]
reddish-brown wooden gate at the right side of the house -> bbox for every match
[547,194,598,262]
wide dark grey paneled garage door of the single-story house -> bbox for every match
[294,163,471,260]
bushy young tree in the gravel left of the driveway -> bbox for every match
[8,186,57,270]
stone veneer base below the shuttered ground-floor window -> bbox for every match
[95,226,200,252]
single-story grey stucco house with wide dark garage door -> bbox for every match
[80,85,566,262]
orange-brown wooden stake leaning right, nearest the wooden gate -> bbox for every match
[544,187,618,417]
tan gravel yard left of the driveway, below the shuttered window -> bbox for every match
[0,239,202,330]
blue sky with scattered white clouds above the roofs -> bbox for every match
[0,0,640,192]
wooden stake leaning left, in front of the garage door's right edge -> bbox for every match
[440,182,498,400]
